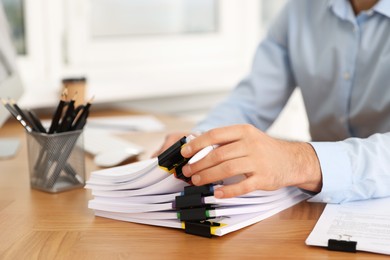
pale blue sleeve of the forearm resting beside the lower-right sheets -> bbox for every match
[309,133,390,203]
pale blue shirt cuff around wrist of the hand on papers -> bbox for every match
[309,142,352,203]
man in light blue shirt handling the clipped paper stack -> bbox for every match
[154,0,390,203]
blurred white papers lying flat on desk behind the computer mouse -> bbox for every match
[87,115,165,132]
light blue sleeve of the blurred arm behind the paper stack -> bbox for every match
[193,0,295,132]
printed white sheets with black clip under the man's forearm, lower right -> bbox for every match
[306,198,390,254]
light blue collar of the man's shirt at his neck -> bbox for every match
[328,0,390,20]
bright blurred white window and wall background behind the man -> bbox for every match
[0,0,308,139]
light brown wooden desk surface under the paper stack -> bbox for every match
[0,108,386,260]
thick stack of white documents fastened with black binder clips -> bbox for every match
[86,158,308,236]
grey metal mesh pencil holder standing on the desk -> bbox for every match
[27,130,85,193]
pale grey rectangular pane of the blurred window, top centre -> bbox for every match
[89,0,219,38]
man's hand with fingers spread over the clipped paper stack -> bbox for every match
[180,125,322,198]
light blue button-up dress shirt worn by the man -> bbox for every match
[195,0,390,203]
